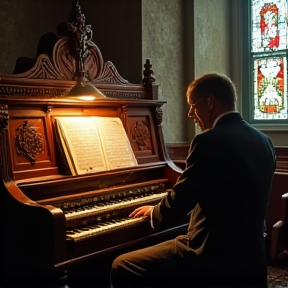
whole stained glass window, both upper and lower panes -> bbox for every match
[251,0,288,122]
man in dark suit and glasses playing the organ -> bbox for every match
[111,73,276,288]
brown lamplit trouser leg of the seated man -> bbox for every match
[110,236,196,288]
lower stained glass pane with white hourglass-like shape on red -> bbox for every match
[254,56,288,120]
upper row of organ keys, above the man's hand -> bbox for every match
[64,191,167,222]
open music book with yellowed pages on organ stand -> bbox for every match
[55,116,138,175]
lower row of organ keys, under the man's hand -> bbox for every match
[66,217,147,242]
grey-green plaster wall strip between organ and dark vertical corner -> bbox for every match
[142,0,193,143]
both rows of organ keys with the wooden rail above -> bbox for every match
[38,179,168,242]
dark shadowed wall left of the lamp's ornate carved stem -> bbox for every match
[0,0,71,73]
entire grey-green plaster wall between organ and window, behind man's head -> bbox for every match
[142,0,231,146]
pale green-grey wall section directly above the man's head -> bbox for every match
[194,0,232,77]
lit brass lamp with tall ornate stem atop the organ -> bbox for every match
[63,0,106,100]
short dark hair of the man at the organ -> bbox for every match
[186,73,237,106]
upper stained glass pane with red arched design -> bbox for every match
[251,0,288,52]
